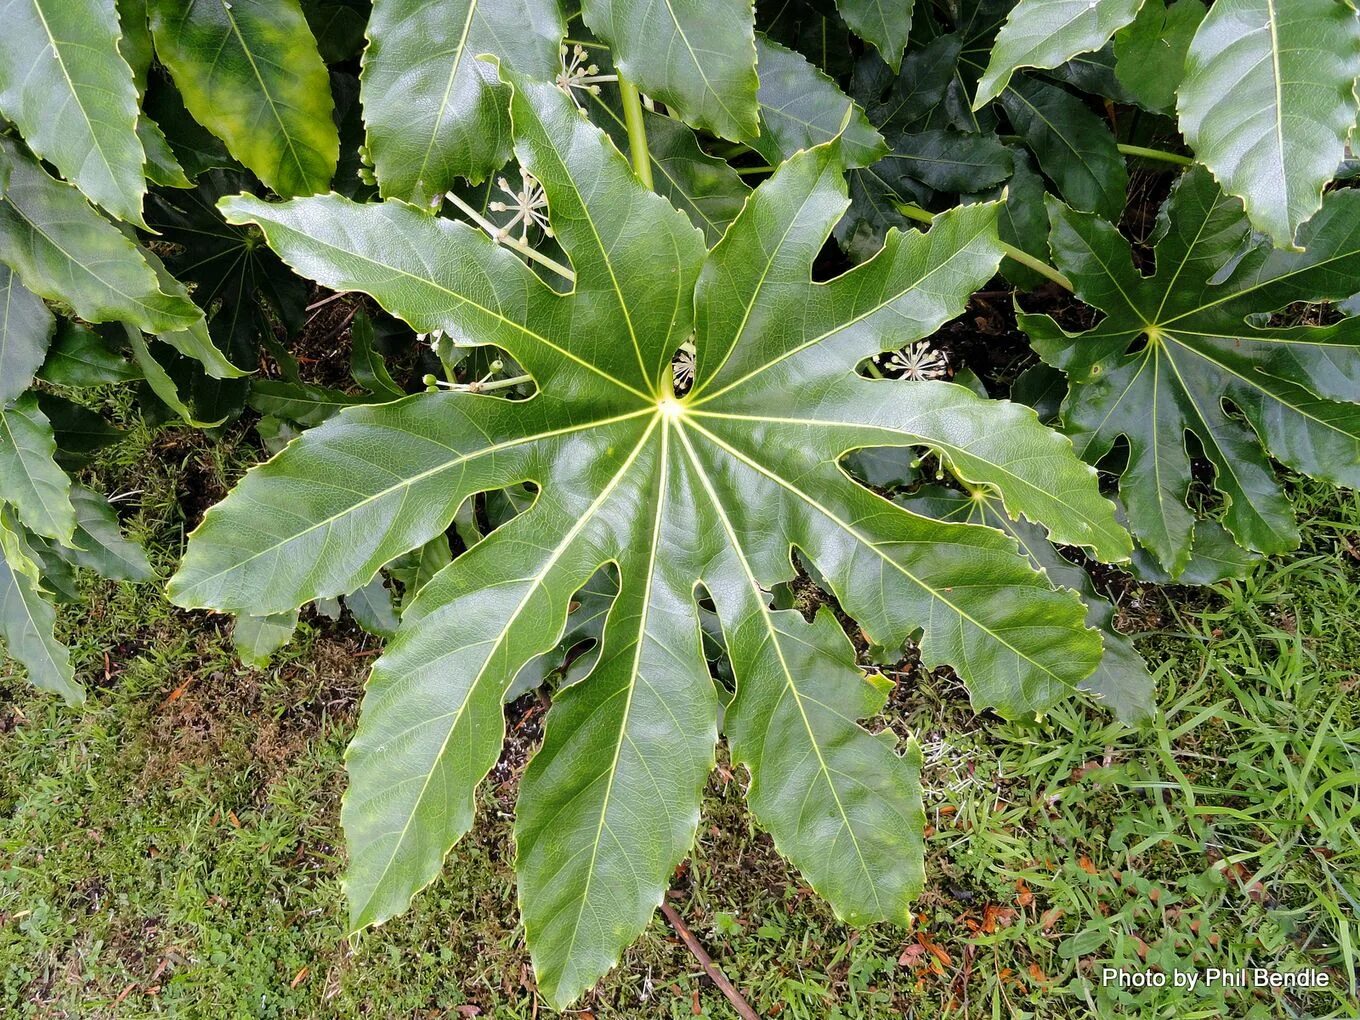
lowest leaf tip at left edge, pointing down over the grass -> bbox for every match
[0,507,84,706]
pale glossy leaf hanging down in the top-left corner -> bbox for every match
[0,0,147,223]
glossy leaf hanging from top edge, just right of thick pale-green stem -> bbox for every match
[581,0,760,141]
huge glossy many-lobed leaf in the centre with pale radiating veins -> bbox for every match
[170,76,1129,1005]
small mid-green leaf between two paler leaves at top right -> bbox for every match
[1114,0,1206,113]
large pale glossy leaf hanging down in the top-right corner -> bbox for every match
[1176,0,1360,246]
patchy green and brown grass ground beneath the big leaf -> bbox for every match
[0,410,1360,1020]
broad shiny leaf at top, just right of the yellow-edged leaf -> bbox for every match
[363,0,566,205]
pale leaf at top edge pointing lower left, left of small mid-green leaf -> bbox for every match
[972,0,1142,110]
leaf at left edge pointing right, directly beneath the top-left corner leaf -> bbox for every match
[0,137,203,340]
